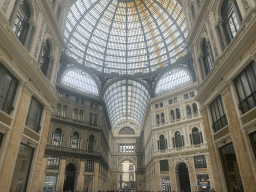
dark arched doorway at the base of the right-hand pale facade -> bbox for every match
[178,163,191,192]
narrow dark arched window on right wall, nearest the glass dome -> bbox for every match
[202,39,213,75]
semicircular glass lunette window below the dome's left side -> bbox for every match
[61,69,99,95]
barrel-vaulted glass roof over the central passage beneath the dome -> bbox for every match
[104,80,150,127]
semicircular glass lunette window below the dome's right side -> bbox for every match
[155,69,193,95]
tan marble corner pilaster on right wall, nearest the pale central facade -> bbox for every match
[202,112,224,191]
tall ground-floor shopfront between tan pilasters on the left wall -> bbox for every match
[10,143,34,192]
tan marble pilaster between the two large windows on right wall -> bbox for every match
[222,88,256,192]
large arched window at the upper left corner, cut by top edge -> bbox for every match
[10,0,31,45]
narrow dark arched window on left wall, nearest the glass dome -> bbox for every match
[38,39,51,76]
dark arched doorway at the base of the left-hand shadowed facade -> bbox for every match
[63,163,76,192]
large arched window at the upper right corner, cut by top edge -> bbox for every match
[221,0,241,43]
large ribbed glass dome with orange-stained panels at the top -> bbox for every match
[65,0,187,74]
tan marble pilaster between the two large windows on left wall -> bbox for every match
[0,85,31,191]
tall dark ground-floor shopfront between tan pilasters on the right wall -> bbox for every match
[219,143,243,192]
